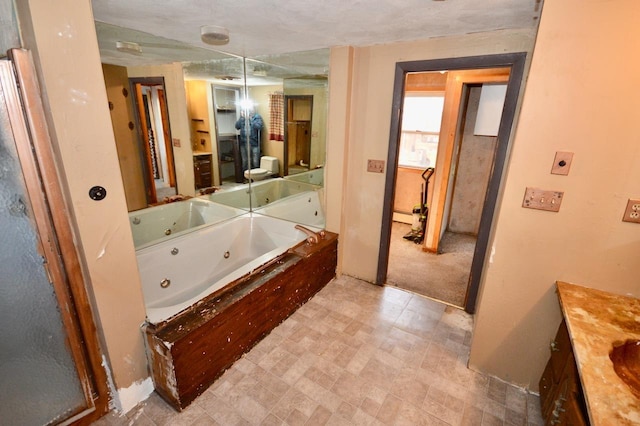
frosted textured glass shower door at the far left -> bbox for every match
[0,55,93,425]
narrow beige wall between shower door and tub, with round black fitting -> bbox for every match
[16,0,151,409]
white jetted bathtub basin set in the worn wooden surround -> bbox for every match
[136,213,319,323]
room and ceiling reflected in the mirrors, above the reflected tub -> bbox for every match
[96,23,328,212]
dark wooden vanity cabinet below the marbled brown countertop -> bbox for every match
[539,320,589,426]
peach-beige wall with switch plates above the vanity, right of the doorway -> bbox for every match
[471,0,640,389]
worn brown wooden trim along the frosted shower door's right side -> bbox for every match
[2,49,109,424]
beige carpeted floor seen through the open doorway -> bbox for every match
[387,222,476,307]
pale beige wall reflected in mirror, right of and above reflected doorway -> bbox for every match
[127,62,195,195]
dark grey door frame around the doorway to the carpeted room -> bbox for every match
[376,52,527,313]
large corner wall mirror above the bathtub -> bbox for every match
[96,22,329,247]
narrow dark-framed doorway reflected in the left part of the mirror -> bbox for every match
[129,77,178,205]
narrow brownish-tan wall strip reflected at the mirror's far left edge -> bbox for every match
[102,64,147,211]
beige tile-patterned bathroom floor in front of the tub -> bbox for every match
[94,276,543,426]
